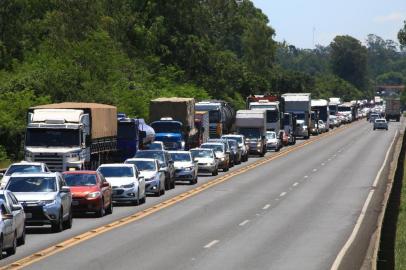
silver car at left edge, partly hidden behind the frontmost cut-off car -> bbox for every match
[0,190,25,246]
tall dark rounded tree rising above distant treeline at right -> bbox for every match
[330,36,367,91]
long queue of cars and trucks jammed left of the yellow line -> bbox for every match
[0,93,396,256]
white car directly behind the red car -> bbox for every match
[97,163,146,205]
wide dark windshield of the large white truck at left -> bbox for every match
[25,128,80,147]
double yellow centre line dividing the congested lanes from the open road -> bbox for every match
[0,121,353,269]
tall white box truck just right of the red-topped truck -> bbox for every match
[282,93,311,139]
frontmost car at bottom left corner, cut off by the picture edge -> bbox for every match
[0,199,18,259]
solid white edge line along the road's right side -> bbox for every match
[330,130,398,270]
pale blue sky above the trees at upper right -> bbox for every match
[252,0,406,48]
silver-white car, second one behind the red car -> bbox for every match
[124,158,165,197]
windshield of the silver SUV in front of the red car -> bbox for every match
[7,177,56,192]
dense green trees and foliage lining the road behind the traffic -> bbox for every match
[0,0,406,159]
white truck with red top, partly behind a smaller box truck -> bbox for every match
[247,94,282,134]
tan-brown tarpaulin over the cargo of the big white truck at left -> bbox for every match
[30,102,117,139]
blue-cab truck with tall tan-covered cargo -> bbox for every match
[149,97,198,150]
